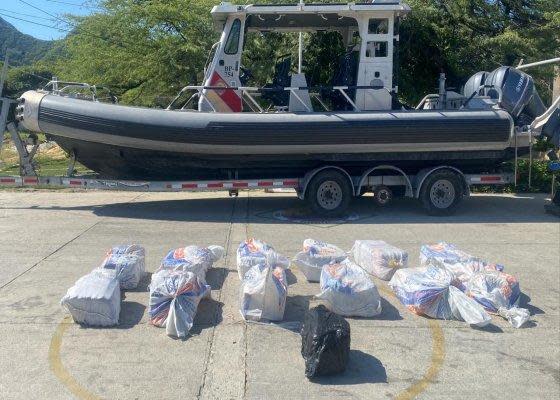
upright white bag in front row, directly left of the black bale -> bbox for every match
[240,263,288,321]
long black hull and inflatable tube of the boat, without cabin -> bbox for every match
[24,95,514,179]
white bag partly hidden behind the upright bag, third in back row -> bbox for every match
[237,239,290,280]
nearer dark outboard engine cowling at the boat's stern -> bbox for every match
[485,67,546,119]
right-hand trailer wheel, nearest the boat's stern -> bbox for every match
[420,171,464,215]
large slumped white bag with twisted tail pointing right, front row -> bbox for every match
[389,266,491,327]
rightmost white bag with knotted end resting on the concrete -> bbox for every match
[465,271,531,328]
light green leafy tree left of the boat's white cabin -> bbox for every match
[56,0,217,105]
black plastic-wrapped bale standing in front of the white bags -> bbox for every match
[301,305,350,379]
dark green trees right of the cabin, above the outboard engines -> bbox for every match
[400,0,560,102]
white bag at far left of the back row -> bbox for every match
[99,244,146,290]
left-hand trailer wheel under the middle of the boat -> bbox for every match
[305,170,352,216]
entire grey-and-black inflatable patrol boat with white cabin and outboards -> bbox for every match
[17,0,557,180]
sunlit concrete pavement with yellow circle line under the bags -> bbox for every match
[0,191,560,399]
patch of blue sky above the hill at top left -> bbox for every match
[0,0,95,40]
